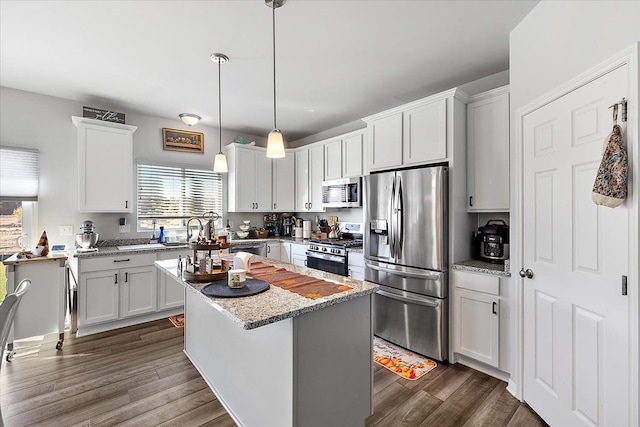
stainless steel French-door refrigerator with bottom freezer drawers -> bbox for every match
[364,166,449,361]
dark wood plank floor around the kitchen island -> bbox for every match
[0,320,546,427]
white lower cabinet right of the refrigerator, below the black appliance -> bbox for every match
[452,271,500,368]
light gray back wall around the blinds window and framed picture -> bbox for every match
[0,87,266,247]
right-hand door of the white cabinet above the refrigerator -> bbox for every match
[402,99,447,165]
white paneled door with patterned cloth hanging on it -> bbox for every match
[523,66,637,426]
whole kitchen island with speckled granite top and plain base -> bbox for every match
[155,256,377,427]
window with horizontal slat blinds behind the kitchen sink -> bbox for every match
[138,163,222,229]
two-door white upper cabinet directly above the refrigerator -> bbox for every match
[362,89,467,171]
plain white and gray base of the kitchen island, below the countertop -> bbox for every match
[185,290,373,427]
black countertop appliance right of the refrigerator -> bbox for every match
[472,219,509,264]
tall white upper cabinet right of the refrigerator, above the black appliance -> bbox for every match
[467,86,509,212]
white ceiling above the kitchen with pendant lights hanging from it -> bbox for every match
[0,0,537,141]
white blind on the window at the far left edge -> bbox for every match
[0,147,40,201]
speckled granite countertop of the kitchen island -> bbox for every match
[155,255,378,329]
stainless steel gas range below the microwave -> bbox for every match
[307,223,362,276]
